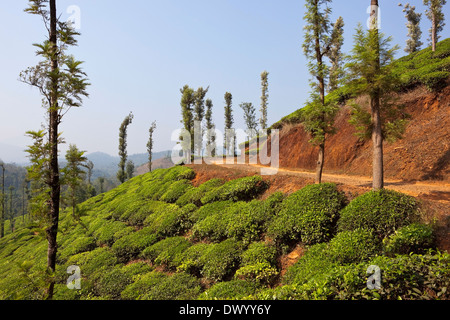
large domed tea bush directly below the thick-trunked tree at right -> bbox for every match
[338,189,417,239]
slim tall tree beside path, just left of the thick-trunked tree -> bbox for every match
[303,0,343,184]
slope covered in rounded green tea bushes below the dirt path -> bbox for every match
[0,167,450,300]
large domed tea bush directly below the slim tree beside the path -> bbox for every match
[268,183,346,245]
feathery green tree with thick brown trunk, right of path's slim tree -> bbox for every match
[346,2,407,190]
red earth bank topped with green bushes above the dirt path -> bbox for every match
[264,39,450,182]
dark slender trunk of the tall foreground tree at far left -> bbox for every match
[46,0,61,299]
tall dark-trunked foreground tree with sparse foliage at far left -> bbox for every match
[20,0,89,299]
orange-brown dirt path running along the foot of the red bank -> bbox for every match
[209,163,450,202]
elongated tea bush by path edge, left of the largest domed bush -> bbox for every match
[201,176,267,204]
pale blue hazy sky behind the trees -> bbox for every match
[0,0,450,162]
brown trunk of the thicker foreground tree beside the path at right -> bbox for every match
[370,0,384,190]
